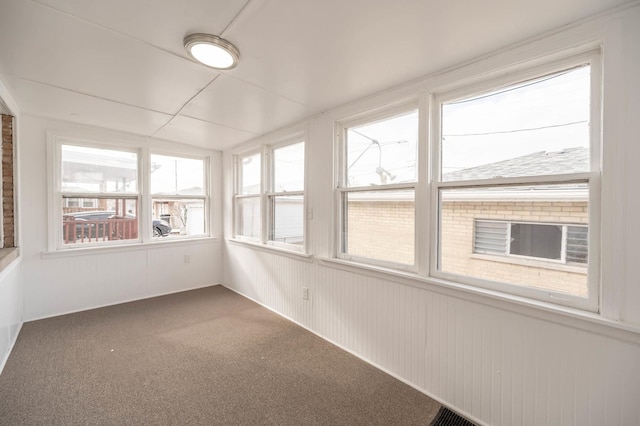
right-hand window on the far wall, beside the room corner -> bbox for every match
[150,154,207,238]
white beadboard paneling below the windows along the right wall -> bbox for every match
[224,248,640,426]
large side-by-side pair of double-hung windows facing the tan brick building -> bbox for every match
[334,52,601,311]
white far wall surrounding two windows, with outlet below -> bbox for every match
[19,115,222,321]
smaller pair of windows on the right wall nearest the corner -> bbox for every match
[234,138,305,251]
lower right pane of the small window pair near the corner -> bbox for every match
[269,196,304,245]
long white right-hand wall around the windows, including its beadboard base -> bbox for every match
[224,6,640,425]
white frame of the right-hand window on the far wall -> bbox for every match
[150,150,211,241]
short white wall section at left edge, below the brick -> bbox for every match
[0,260,22,372]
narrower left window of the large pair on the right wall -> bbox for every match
[337,106,418,270]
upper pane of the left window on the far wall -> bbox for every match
[62,145,138,193]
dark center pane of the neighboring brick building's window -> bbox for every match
[510,223,562,260]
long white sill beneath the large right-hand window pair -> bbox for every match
[316,257,640,344]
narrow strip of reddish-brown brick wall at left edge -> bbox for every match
[2,114,15,247]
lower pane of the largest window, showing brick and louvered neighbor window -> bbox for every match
[438,183,589,296]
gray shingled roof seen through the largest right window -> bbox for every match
[442,147,589,181]
